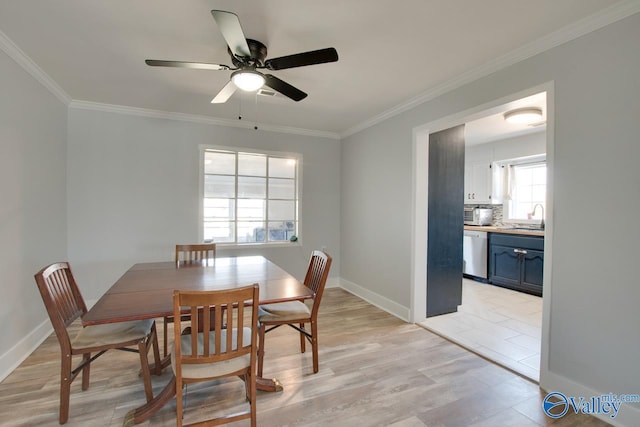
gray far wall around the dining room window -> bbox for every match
[68,108,340,299]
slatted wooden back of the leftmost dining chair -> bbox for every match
[35,262,87,352]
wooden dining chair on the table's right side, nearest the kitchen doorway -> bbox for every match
[258,251,332,377]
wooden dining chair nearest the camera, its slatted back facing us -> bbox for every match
[171,283,259,427]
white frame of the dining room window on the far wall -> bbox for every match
[198,144,302,248]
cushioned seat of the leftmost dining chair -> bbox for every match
[71,319,153,350]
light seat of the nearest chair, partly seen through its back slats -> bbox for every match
[171,328,251,379]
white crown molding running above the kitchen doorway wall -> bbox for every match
[340,0,640,138]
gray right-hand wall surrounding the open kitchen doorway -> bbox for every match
[341,14,640,425]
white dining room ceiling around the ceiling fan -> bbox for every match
[0,0,633,135]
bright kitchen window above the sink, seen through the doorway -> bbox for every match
[506,159,547,221]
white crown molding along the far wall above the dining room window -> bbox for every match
[69,100,340,140]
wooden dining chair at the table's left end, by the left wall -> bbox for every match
[35,262,161,424]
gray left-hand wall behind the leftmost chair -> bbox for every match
[0,51,67,379]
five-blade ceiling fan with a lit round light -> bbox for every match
[145,10,338,104]
